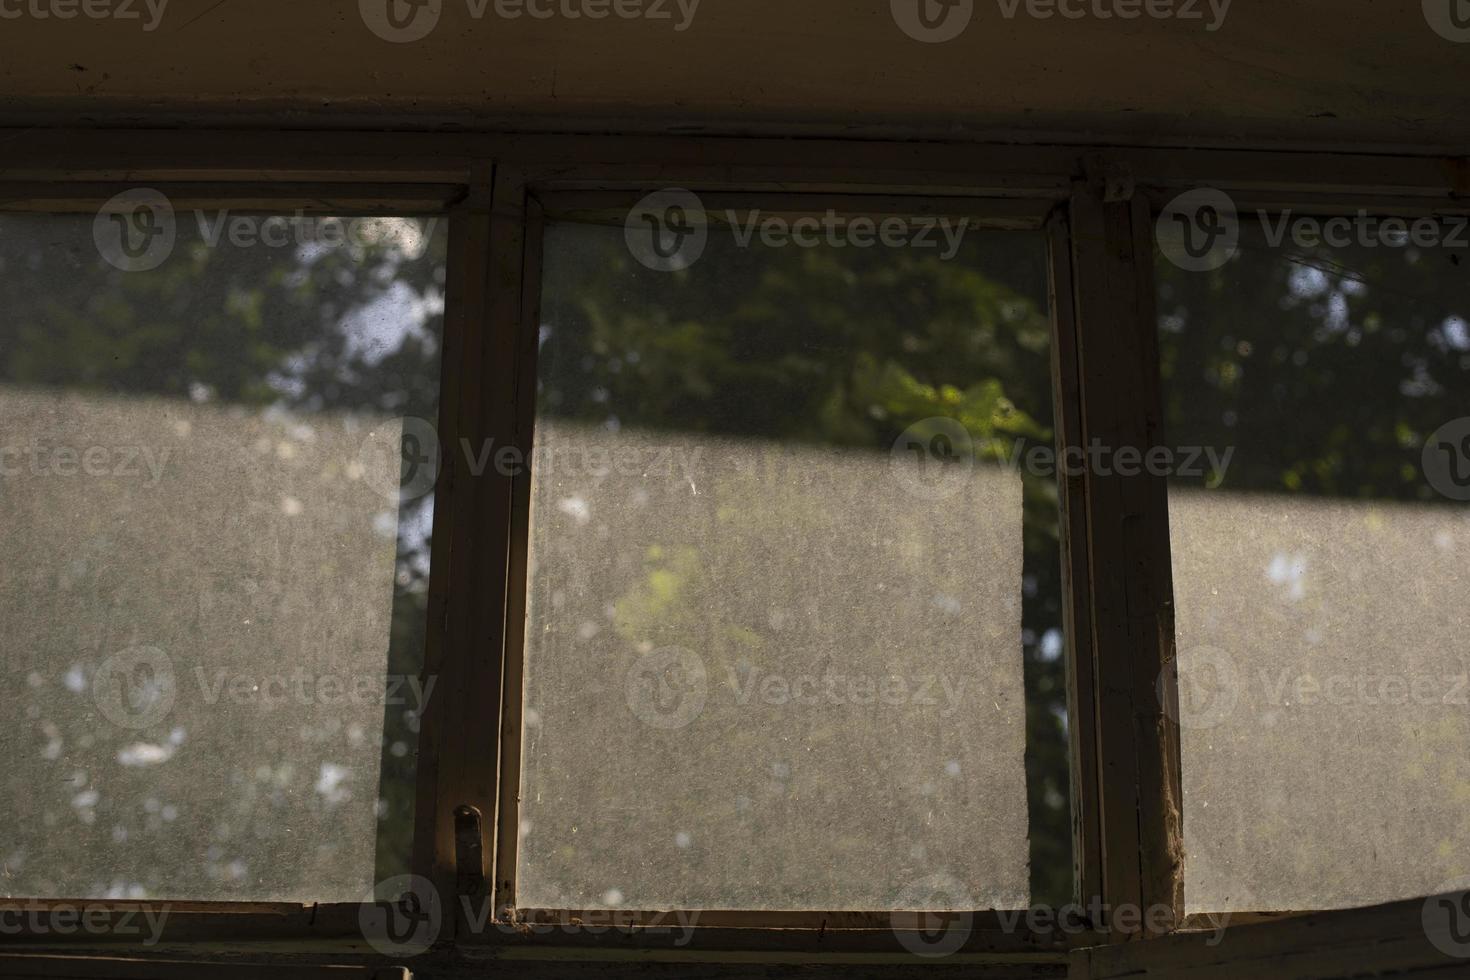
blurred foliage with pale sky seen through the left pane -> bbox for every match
[0,213,445,898]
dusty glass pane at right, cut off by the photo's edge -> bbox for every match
[1158,216,1470,911]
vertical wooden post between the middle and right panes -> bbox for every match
[1069,157,1183,940]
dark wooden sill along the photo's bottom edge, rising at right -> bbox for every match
[0,899,1470,980]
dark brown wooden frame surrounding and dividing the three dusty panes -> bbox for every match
[0,128,1470,976]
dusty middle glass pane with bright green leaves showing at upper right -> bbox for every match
[517,214,1072,909]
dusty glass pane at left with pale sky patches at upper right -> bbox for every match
[0,212,444,902]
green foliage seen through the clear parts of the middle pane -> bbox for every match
[539,225,1073,904]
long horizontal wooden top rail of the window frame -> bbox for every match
[0,126,1470,201]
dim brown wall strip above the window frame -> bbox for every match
[0,0,1470,153]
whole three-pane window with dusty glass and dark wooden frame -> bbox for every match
[0,134,1470,974]
